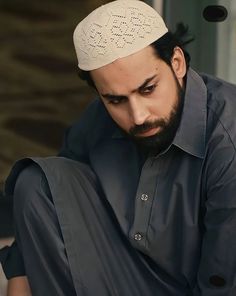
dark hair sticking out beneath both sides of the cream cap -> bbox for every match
[78,23,194,89]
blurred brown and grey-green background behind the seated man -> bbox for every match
[0,0,236,295]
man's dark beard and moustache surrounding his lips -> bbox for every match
[128,73,185,155]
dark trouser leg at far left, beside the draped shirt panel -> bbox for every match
[14,165,76,296]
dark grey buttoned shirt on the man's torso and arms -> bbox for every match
[60,69,236,296]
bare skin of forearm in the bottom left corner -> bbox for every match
[7,276,32,296]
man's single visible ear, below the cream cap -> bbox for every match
[171,46,187,82]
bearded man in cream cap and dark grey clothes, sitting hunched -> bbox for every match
[0,0,236,296]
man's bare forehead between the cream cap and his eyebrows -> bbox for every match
[91,46,161,93]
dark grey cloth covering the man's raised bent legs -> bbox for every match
[14,160,179,296]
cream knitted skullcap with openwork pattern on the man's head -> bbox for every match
[73,0,168,71]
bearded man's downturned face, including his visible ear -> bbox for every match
[91,46,186,153]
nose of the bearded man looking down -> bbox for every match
[129,98,150,125]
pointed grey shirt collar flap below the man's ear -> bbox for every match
[173,68,207,158]
